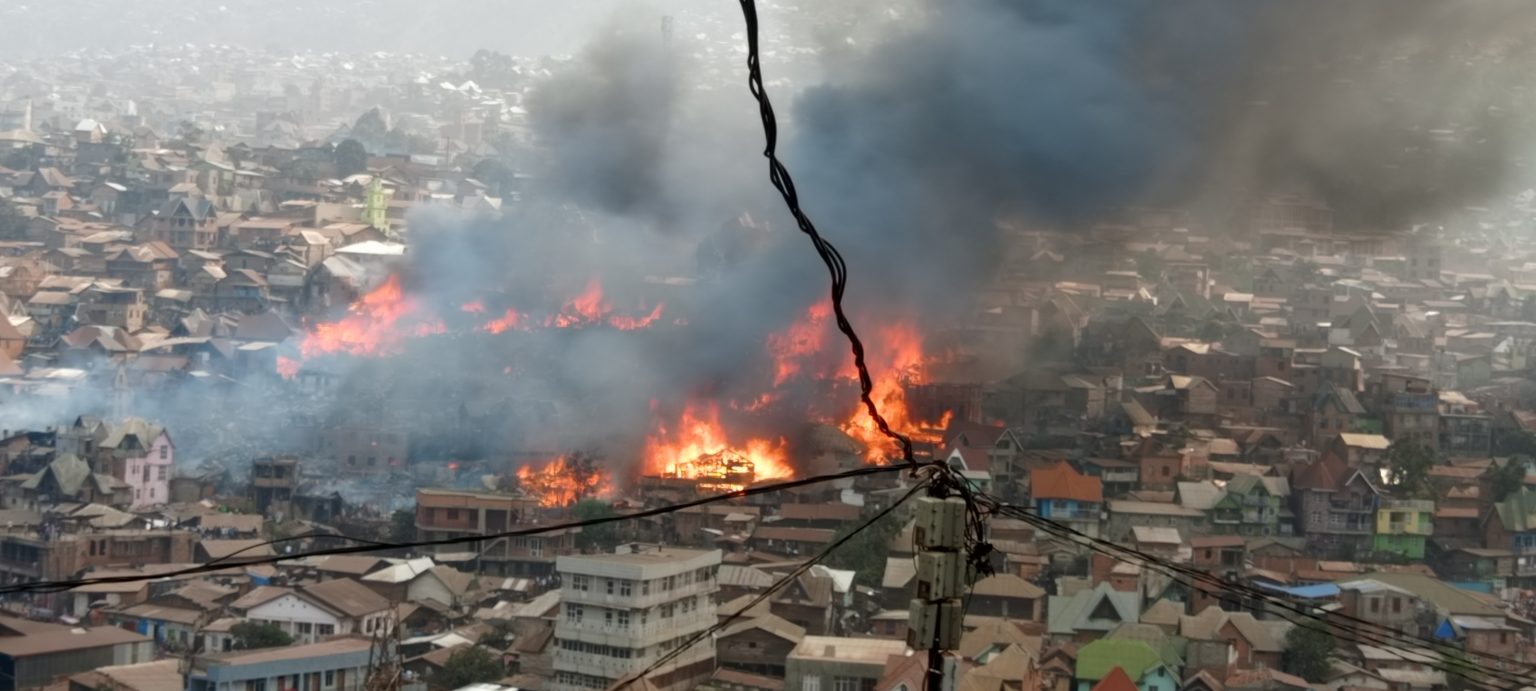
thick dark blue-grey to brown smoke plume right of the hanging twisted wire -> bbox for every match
[796,0,1536,290]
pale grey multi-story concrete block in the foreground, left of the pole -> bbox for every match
[548,547,720,691]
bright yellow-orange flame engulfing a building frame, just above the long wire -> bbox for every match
[645,404,794,491]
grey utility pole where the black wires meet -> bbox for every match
[906,488,968,691]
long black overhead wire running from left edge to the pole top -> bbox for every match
[0,465,909,594]
